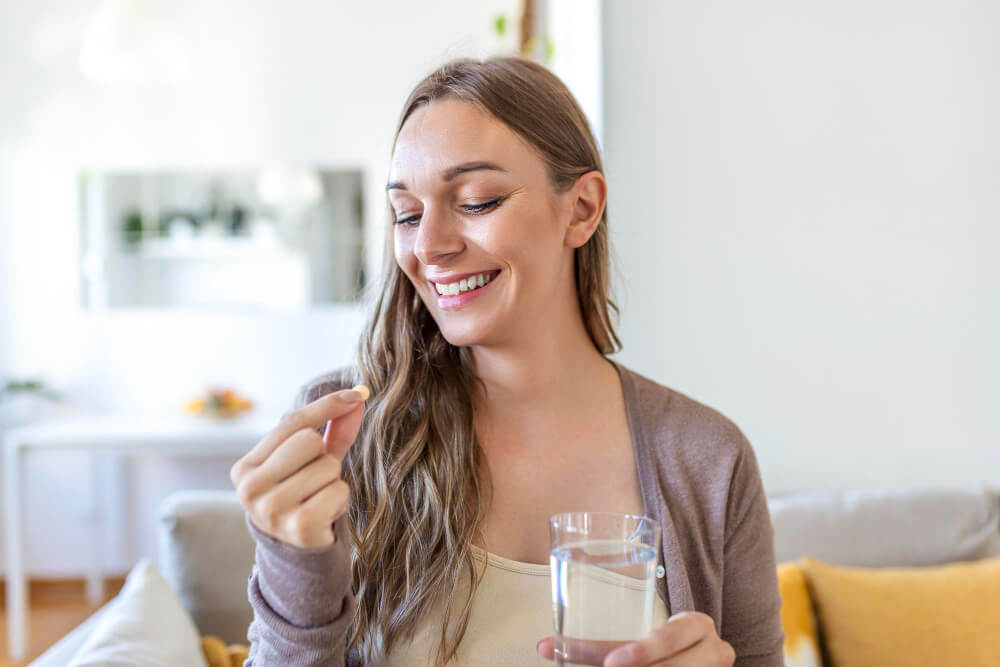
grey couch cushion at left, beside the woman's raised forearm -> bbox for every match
[158,491,254,644]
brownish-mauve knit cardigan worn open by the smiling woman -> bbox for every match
[245,362,784,667]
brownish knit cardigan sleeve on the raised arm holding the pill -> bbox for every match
[243,376,354,667]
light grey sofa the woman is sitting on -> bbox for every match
[32,484,1000,667]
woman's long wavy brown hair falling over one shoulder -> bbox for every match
[344,57,621,664]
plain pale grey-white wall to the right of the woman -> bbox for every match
[603,0,1000,493]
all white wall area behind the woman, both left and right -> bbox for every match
[0,0,1000,575]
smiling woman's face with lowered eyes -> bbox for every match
[388,100,575,346]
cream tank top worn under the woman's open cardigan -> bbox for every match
[382,545,667,667]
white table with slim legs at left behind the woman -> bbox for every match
[4,415,280,660]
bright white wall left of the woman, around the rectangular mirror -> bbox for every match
[0,0,520,575]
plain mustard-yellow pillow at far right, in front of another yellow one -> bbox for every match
[803,558,1000,667]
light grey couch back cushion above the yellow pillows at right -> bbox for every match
[768,485,1000,567]
